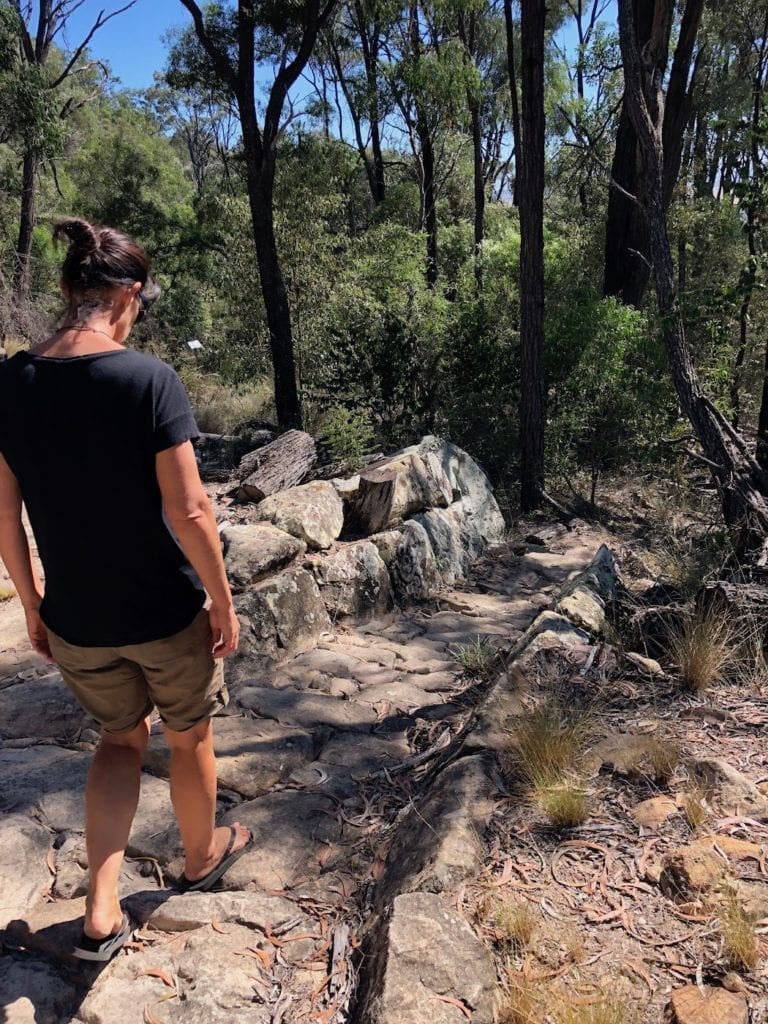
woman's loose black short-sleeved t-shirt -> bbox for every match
[0,348,205,647]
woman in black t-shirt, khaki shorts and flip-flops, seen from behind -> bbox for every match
[0,219,252,961]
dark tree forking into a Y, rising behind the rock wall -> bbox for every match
[179,0,337,427]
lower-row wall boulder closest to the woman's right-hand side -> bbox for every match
[236,568,331,660]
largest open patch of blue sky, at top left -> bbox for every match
[62,0,186,89]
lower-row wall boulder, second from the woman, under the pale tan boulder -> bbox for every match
[305,541,392,622]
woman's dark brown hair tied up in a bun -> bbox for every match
[53,217,160,302]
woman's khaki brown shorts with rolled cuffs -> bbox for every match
[48,610,229,732]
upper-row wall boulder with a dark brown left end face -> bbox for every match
[351,452,453,534]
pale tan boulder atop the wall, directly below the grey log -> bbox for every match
[256,480,344,551]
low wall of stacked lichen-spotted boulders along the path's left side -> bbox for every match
[221,436,505,681]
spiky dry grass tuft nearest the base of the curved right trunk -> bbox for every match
[669,611,739,693]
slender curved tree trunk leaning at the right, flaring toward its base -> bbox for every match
[618,0,768,566]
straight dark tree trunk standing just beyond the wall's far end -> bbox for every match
[520,0,546,511]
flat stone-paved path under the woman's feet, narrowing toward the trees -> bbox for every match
[0,526,599,1024]
